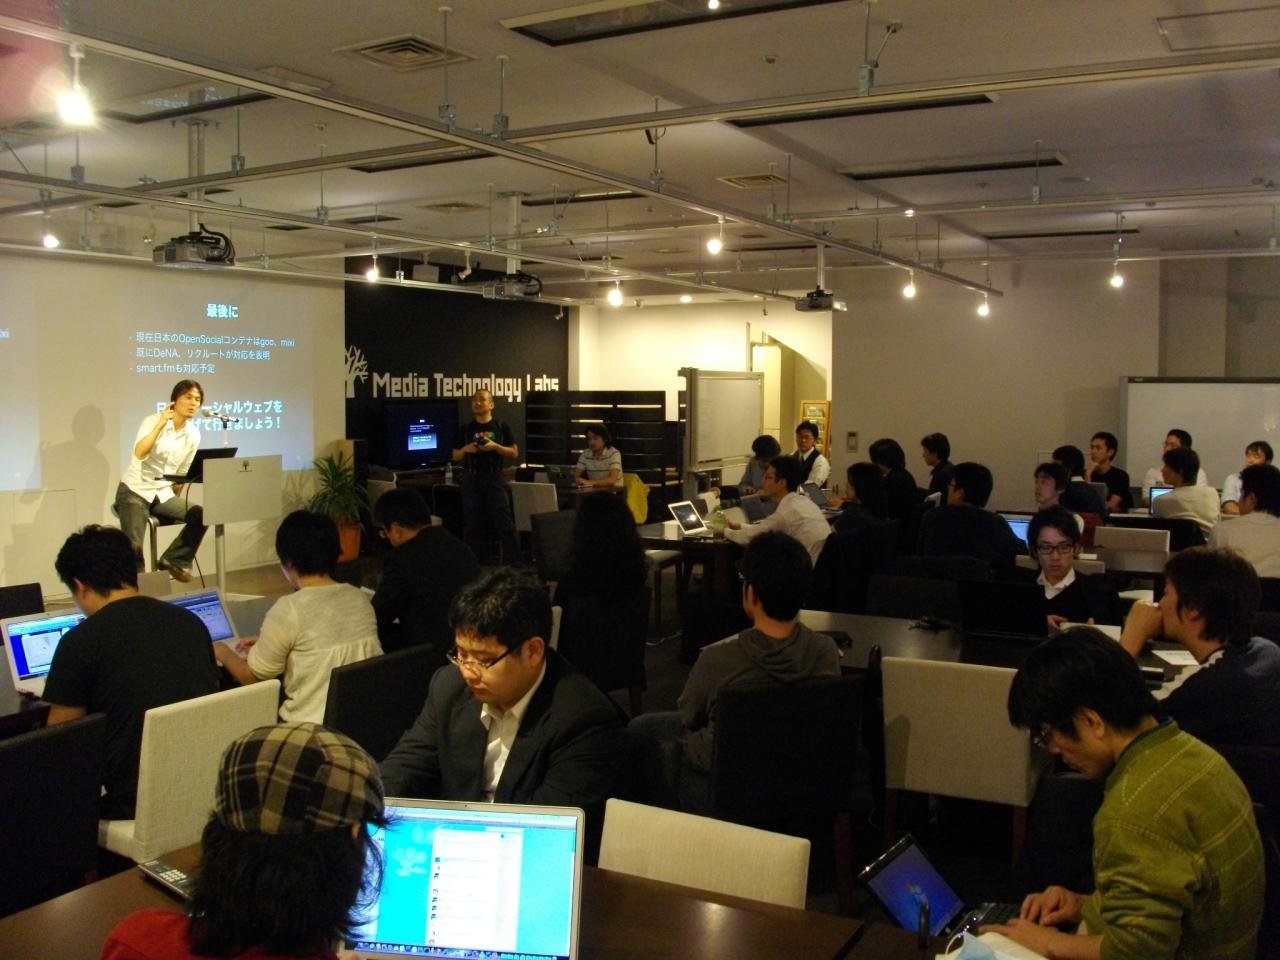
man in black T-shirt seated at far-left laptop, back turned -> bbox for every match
[44,525,221,820]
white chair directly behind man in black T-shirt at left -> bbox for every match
[97,680,280,863]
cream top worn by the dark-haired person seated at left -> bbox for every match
[248,584,383,723]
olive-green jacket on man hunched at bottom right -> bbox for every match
[1084,722,1265,960]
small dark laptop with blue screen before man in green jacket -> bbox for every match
[858,833,1019,938]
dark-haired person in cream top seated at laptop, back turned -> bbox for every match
[214,509,383,723]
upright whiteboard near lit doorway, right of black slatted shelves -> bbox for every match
[680,367,764,471]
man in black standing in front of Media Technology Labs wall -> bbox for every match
[453,388,520,566]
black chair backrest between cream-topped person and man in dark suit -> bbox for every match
[324,645,444,760]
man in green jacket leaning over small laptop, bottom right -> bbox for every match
[987,627,1265,960]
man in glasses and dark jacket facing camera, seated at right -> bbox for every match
[1015,507,1121,632]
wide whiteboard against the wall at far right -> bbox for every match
[1120,376,1280,488]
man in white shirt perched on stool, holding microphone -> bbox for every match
[115,380,205,584]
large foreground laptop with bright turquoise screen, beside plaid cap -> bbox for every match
[347,797,585,960]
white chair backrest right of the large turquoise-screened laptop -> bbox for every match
[600,797,809,910]
